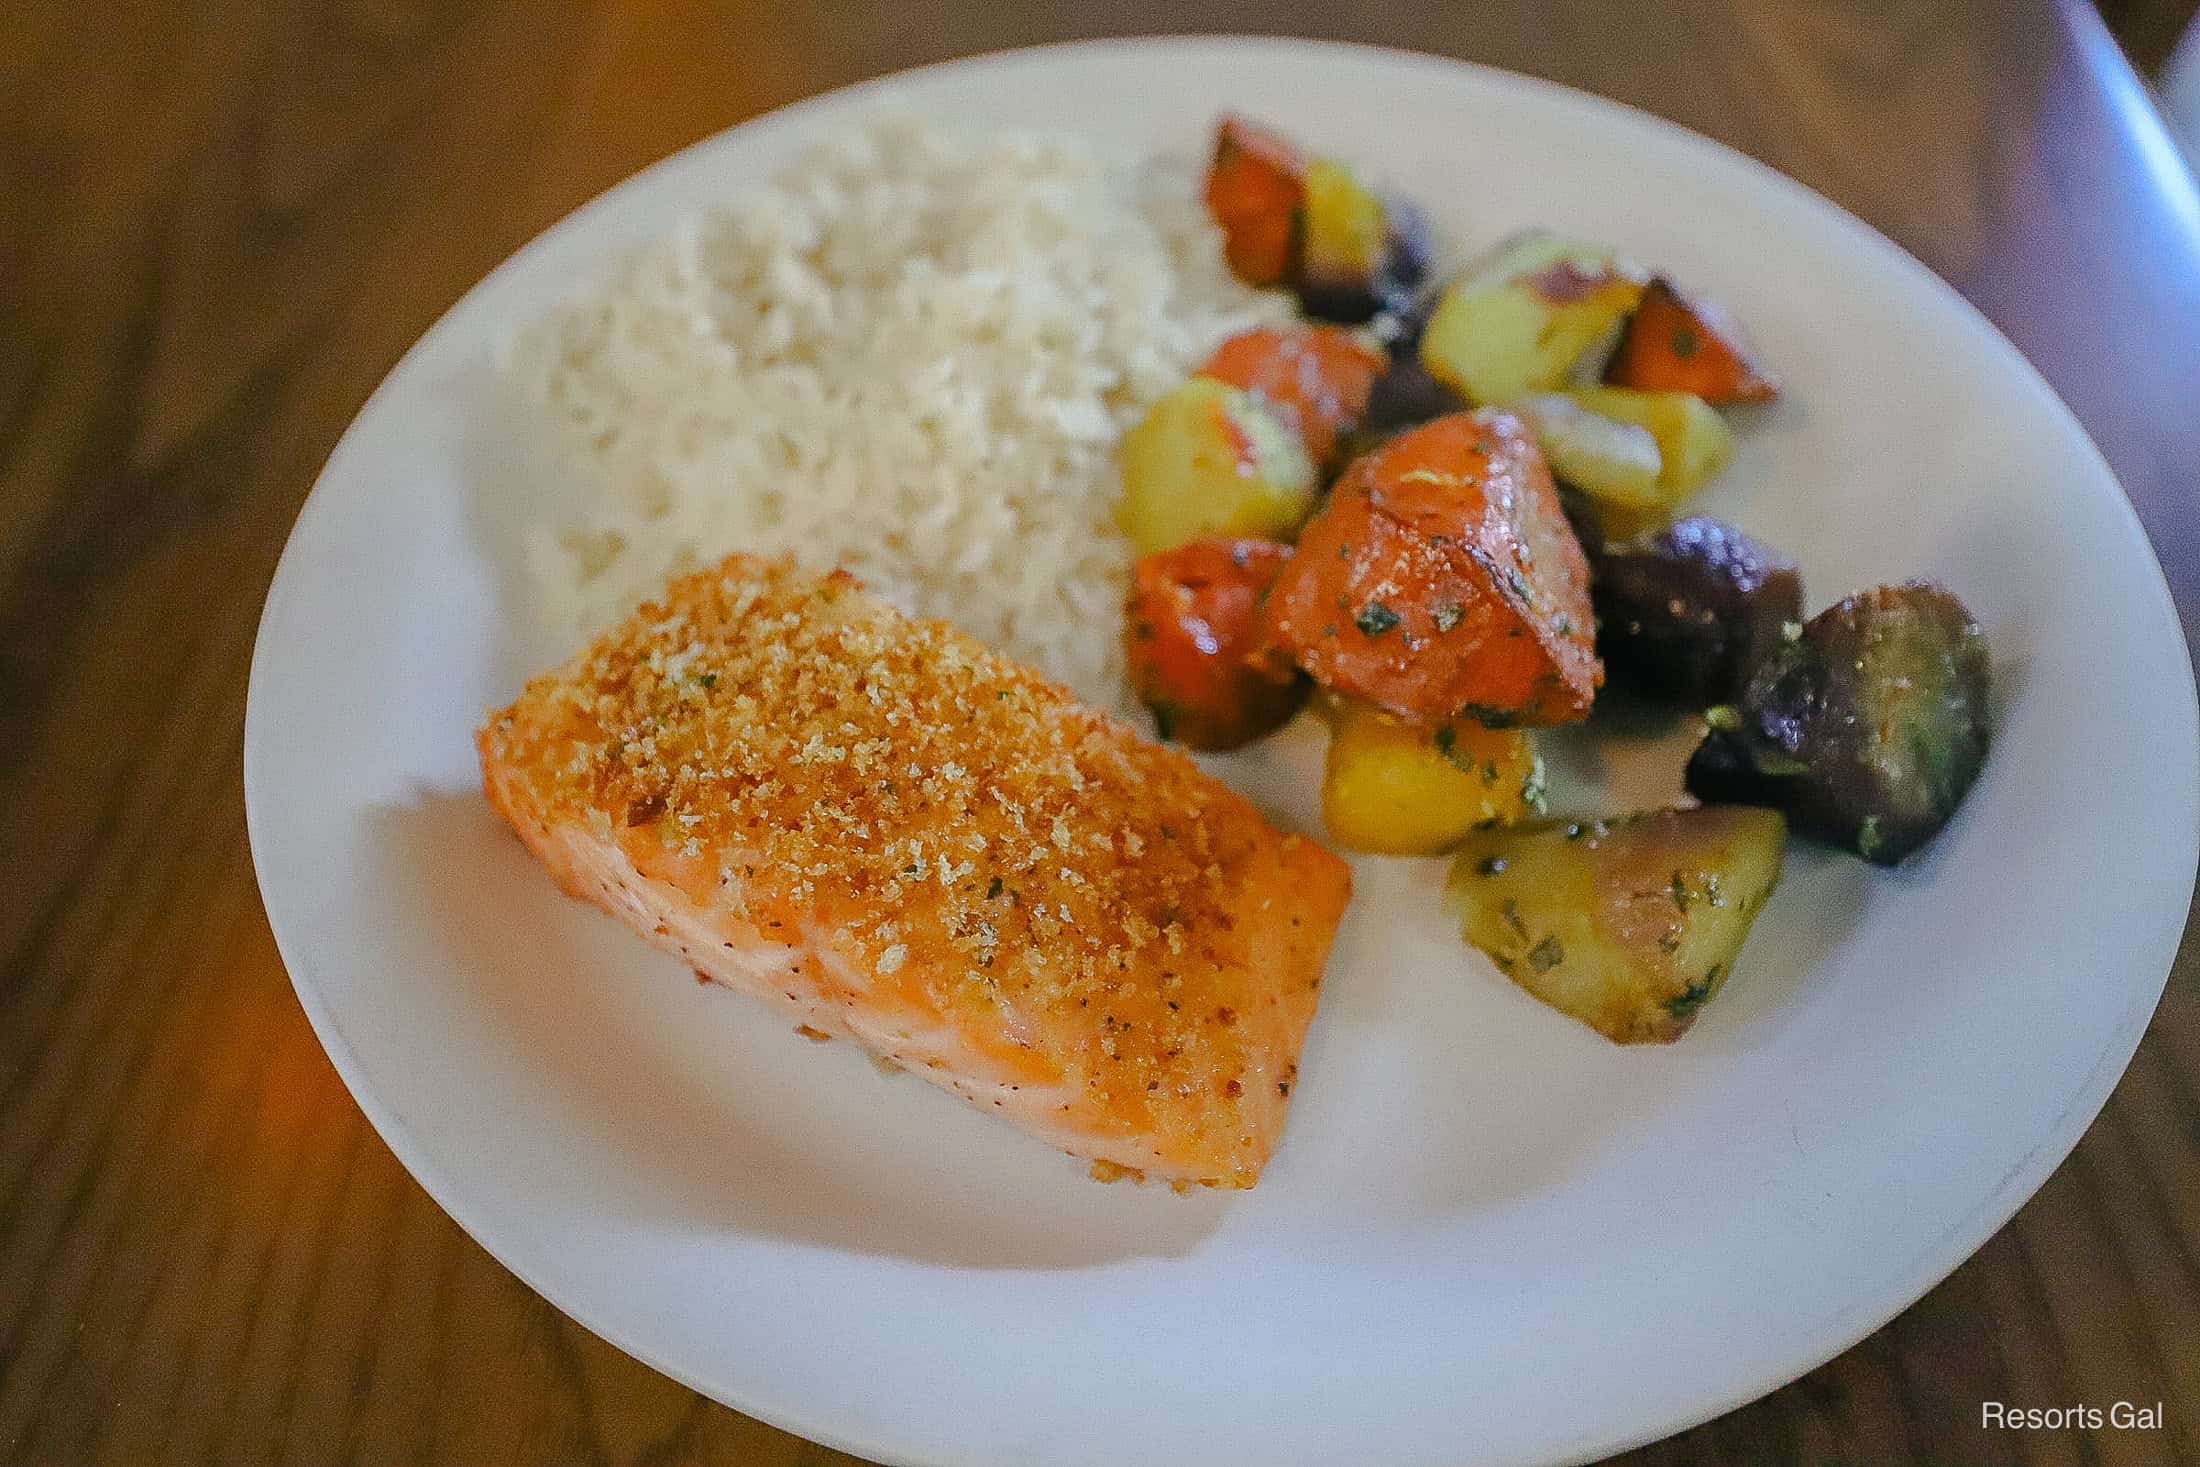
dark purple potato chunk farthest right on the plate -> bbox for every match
[1687,581,1993,867]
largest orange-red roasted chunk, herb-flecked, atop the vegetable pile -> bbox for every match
[1265,409,1604,726]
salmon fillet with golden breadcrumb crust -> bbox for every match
[477,554,1351,1188]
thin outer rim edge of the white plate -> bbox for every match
[242,33,2200,1467]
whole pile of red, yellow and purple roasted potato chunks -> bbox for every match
[1118,117,1991,1043]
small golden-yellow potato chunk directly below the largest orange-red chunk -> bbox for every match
[1322,699,1544,856]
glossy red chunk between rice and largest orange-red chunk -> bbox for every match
[1124,539,1307,750]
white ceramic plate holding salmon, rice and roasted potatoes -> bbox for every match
[246,40,2200,1467]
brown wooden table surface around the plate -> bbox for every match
[0,0,2200,1465]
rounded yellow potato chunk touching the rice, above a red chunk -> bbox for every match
[1115,376,1318,554]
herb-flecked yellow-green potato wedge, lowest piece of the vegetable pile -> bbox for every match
[1445,807,1786,1045]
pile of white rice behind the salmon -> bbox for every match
[508,114,1291,706]
